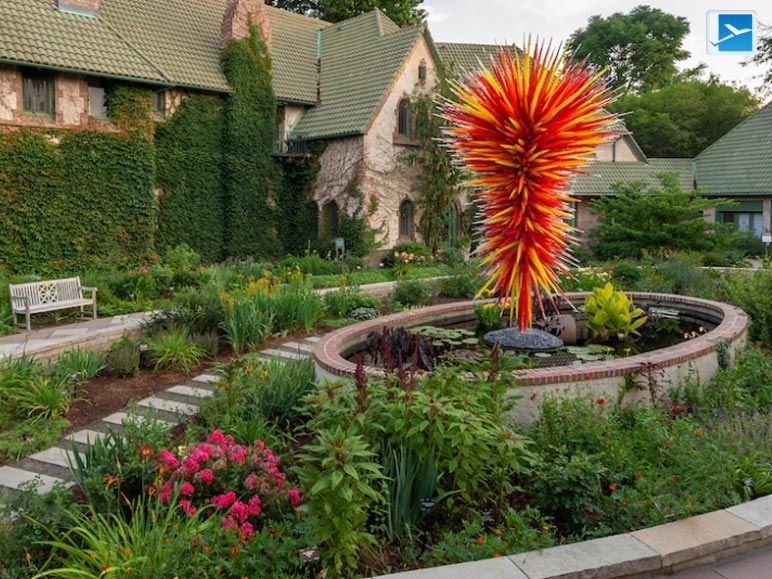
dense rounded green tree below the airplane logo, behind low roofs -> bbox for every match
[609,77,758,157]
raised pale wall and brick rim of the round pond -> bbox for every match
[314,292,748,421]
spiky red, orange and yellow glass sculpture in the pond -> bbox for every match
[443,40,616,330]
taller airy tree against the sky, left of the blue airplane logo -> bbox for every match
[568,6,689,93]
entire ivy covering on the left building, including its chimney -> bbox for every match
[0,28,321,275]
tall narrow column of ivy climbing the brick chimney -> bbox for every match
[222,23,281,257]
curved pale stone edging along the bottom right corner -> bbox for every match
[380,495,772,579]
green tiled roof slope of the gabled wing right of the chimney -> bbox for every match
[293,10,425,139]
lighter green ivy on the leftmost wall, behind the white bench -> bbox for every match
[0,90,156,274]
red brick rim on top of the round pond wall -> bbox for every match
[314,292,748,386]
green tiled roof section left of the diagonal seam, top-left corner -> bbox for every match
[0,0,166,82]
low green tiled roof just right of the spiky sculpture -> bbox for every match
[573,159,693,197]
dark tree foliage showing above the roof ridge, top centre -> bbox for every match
[266,0,426,26]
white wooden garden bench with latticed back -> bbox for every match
[8,277,97,332]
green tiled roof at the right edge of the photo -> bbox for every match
[695,103,772,196]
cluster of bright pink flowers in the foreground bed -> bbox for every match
[158,430,300,541]
